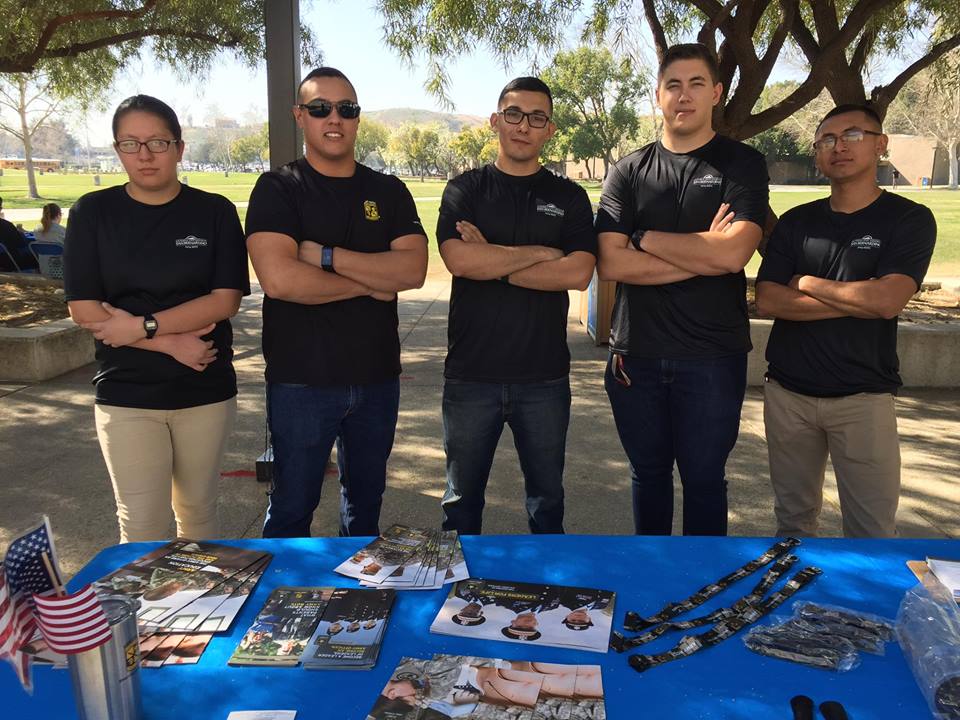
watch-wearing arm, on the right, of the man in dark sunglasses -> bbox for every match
[300,235,427,299]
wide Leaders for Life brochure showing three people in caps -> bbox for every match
[430,579,616,652]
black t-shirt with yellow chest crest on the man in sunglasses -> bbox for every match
[246,158,423,385]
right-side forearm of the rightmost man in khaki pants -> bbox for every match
[796,273,917,320]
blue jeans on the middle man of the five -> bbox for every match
[442,377,570,535]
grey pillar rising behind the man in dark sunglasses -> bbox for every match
[264,0,303,169]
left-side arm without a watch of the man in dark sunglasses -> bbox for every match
[247,232,372,305]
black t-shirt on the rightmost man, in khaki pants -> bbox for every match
[757,192,937,397]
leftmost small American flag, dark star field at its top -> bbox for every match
[0,517,59,691]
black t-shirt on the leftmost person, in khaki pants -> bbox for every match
[64,185,250,410]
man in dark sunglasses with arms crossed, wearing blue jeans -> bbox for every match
[246,67,427,537]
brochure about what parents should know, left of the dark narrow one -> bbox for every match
[227,587,334,666]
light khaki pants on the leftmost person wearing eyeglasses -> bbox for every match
[95,397,237,542]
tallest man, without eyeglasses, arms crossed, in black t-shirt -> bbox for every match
[597,44,768,535]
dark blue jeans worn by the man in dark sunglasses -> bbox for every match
[263,380,400,537]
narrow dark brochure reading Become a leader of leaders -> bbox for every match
[300,588,396,670]
